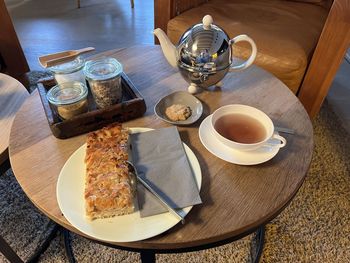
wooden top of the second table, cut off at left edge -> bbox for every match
[0,73,29,164]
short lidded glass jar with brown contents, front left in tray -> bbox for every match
[46,81,88,120]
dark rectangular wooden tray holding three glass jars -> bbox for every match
[37,73,146,139]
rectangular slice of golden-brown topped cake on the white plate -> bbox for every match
[85,123,134,220]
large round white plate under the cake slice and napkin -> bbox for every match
[56,128,202,242]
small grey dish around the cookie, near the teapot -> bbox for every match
[154,91,203,125]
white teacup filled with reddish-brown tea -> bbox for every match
[211,104,287,151]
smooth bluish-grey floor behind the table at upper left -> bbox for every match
[5,0,154,70]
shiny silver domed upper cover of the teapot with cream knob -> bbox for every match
[178,15,231,74]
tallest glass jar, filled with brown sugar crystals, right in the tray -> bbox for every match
[84,58,123,109]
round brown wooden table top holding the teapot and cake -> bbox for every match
[9,46,314,252]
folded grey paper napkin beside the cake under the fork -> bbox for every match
[130,127,202,217]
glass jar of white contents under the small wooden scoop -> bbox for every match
[48,56,85,84]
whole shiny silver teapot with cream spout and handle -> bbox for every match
[154,15,257,93]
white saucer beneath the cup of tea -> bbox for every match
[199,115,280,165]
